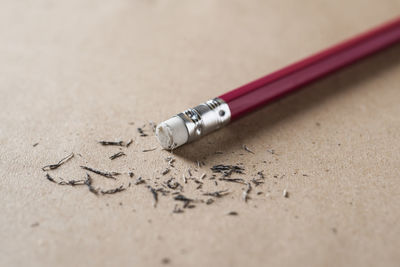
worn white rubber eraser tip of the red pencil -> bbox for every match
[156,116,189,149]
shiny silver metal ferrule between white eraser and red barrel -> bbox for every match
[177,98,231,142]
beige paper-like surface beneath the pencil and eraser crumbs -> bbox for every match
[0,0,400,266]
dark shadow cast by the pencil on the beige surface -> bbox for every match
[173,44,400,161]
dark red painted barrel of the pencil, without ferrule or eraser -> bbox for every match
[219,17,400,121]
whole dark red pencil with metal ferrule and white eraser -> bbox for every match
[156,17,400,149]
